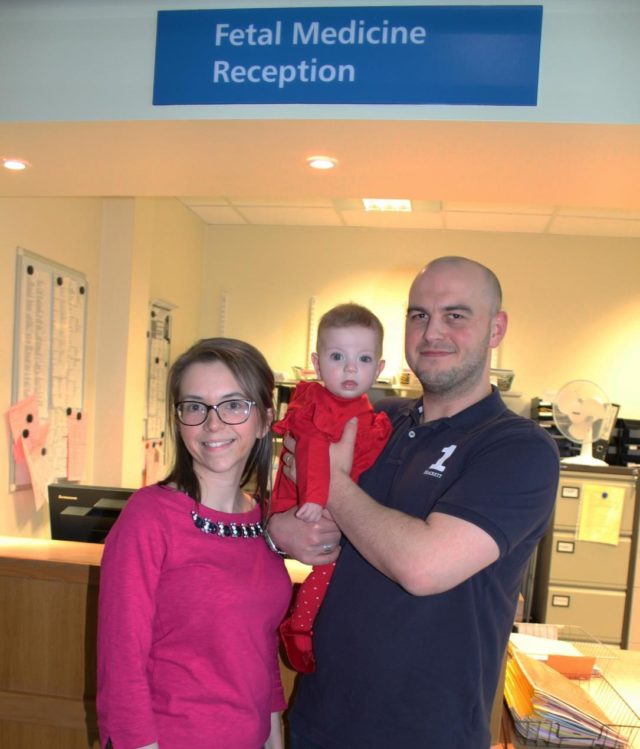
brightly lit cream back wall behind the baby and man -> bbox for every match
[203,227,640,418]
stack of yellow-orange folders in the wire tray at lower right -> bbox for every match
[505,645,629,749]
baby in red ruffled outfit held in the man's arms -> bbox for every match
[271,304,391,673]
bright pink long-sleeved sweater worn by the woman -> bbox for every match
[97,485,291,749]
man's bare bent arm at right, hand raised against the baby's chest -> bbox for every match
[328,421,499,595]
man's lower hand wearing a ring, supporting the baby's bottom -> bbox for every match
[269,507,340,564]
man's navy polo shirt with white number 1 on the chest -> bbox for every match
[290,389,559,749]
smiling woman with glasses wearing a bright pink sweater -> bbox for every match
[97,338,291,749]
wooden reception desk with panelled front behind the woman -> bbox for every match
[0,537,309,749]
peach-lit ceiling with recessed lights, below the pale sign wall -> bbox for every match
[0,120,640,237]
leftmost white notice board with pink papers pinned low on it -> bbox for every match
[9,247,88,496]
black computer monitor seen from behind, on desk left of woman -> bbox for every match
[48,483,135,544]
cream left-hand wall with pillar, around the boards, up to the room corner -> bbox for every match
[0,198,204,537]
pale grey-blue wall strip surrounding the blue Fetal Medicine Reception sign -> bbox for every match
[0,0,640,123]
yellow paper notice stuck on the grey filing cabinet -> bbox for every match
[577,484,624,546]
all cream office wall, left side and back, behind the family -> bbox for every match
[0,198,640,537]
